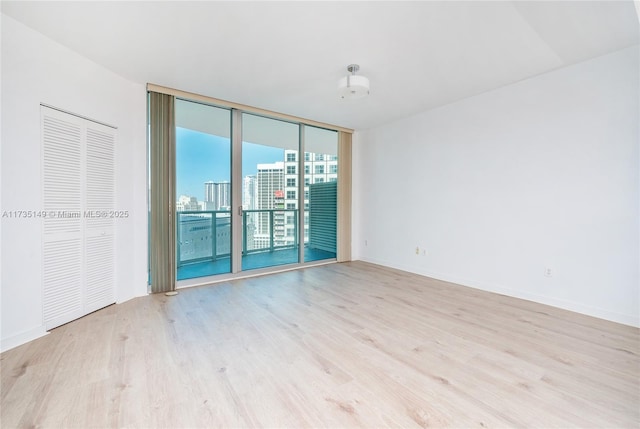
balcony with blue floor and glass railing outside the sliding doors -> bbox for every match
[176,209,336,280]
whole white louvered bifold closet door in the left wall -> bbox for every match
[41,106,115,329]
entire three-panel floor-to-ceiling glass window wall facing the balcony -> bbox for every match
[150,85,344,285]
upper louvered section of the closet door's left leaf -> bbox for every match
[42,116,82,234]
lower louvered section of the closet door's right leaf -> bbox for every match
[85,235,115,312]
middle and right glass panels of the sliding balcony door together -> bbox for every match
[242,114,338,270]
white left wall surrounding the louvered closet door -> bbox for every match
[0,15,147,350]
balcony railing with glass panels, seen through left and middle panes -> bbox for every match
[176,209,298,267]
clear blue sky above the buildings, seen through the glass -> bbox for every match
[176,127,284,201]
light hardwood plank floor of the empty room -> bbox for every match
[1,262,640,429]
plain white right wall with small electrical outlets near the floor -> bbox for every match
[353,46,640,326]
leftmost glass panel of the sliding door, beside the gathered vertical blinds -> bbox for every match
[175,99,233,280]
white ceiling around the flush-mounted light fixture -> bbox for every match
[2,1,640,129]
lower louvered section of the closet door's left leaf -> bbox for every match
[43,238,83,328]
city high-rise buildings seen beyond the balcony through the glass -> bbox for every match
[176,150,338,259]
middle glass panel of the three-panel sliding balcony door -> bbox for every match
[242,113,300,270]
